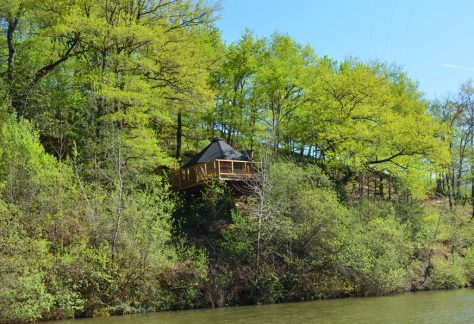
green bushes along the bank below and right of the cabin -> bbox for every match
[221,162,471,302]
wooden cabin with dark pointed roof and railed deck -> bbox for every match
[170,138,255,190]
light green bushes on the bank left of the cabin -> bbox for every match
[0,116,207,322]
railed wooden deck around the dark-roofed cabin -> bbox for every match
[170,160,255,190]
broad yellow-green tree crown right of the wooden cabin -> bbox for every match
[297,60,447,196]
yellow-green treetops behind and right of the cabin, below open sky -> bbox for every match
[209,31,450,198]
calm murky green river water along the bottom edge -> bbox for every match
[50,289,474,324]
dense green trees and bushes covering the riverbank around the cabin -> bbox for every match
[0,0,474,322]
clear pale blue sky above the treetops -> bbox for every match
[217,0,474,99]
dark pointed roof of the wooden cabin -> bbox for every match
[182,138,250,168]
